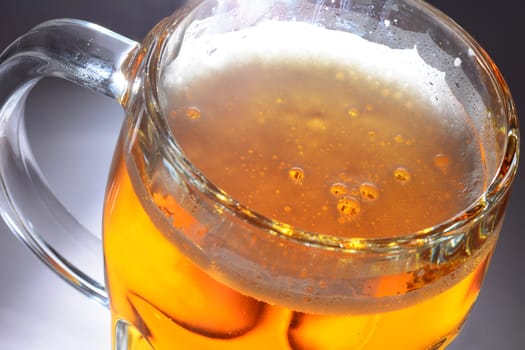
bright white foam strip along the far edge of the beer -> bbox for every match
[161,20,464,123]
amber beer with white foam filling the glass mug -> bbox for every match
[104,23,494,350]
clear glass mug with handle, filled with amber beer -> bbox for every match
[0,0,519,350]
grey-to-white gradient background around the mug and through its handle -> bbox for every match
[0,0,525,350]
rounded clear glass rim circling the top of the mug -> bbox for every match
[144,0,519,255]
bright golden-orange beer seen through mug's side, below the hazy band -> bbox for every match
[104,156,488,350]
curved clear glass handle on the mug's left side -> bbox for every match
[0,19,139,307]
